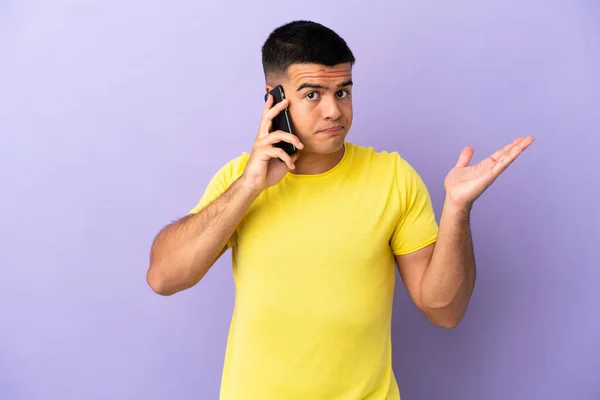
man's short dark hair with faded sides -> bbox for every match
[262,21,355,77]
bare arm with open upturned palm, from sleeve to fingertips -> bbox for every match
[396,137,534,328]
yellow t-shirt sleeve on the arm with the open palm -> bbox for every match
[390,153,438,255]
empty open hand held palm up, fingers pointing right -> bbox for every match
[444,136,534,206]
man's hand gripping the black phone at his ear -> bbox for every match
[241,96,304,193]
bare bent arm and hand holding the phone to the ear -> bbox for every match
[146,96,304,296]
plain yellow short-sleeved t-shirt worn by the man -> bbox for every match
[191,142,438,400]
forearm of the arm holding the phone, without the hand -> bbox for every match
[147,179,258,295]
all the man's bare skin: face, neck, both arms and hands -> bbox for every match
[147,64,534,328]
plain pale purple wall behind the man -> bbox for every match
[0,0,600,400]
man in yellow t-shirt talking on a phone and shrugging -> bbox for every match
[147,21,533,400]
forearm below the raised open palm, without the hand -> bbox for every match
[421,195,475,326]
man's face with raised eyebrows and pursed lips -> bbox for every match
[267,63,352,154]
